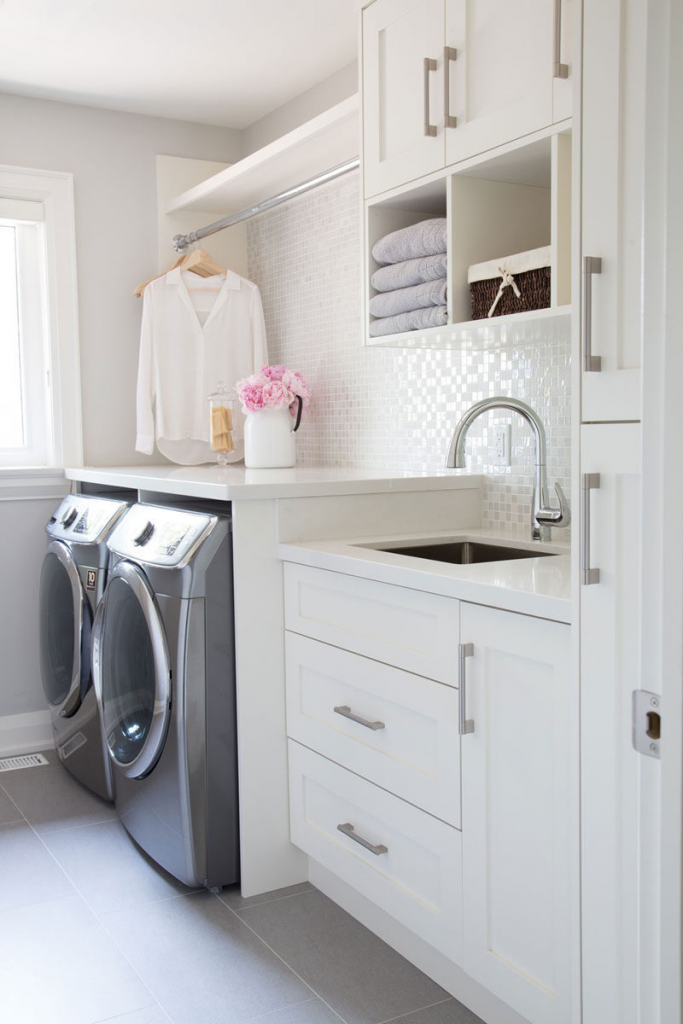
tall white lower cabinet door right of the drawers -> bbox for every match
[460,603,578,1024]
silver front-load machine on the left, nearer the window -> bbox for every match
[39,495,129,801]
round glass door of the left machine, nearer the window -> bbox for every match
[39,541,91,718]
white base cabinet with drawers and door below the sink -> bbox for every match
[286,569,577,1024]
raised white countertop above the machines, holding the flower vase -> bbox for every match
[65,464,482,502]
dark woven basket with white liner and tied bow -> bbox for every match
[467,246,550,319]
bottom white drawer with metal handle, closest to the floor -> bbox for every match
[289,739,462,961]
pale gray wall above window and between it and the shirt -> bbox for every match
[0,94,242,466]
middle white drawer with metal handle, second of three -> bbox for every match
[286,633,460,827]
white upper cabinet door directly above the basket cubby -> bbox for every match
[444,0,563,164]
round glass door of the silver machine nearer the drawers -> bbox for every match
[92,561,171,778]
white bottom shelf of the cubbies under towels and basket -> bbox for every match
[366,305,571,352]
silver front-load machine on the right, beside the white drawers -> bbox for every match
[92,504,240,891]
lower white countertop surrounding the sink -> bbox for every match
[279,529,571,623]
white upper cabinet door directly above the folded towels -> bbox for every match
[362,0,444,197]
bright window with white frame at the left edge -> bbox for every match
[0,167,82,479]
